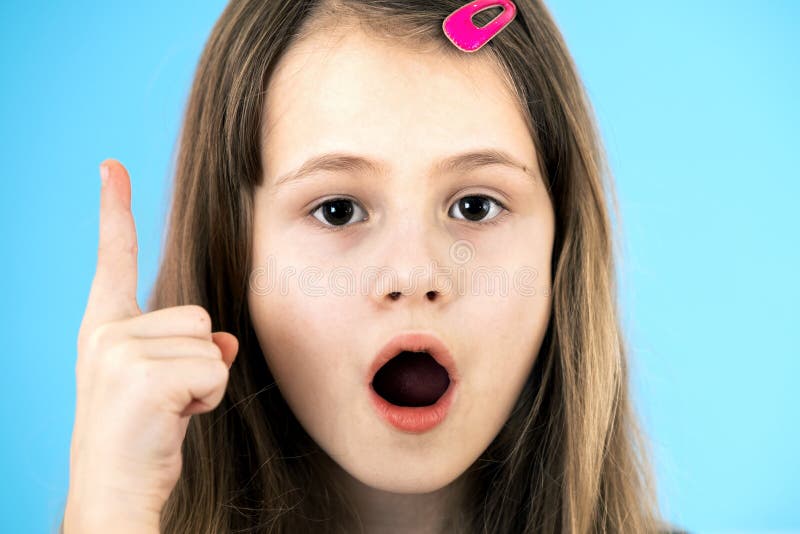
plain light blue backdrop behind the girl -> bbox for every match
[0,0,800,532]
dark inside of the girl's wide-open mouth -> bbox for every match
[372,351,450,406]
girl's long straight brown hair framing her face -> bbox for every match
[147,0,660,533]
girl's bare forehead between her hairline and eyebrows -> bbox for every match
[261,27,535,179]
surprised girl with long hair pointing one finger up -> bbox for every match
[62,0,676,533]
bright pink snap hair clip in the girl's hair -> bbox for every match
[442,0,517,52]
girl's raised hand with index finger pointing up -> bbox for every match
[62,159,239,534]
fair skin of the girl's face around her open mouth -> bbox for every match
[248,28,554,493]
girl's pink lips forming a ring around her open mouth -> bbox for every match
[366,332,460,433]
